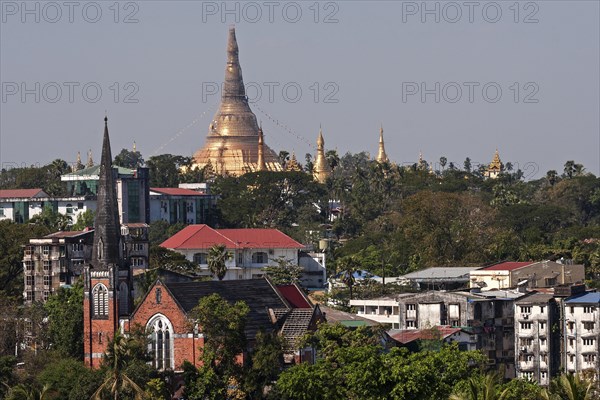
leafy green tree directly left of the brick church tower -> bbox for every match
[44,282,83,360]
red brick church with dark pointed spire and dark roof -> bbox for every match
[83,118,324,372]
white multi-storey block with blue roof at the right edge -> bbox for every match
[563,292,600,377]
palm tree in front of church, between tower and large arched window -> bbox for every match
[92,331,144,400]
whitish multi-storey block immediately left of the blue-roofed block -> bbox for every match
[515,292,561,386]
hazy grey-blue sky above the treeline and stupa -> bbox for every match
[0,0,600,179]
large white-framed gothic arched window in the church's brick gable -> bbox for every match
[146,314,174,370]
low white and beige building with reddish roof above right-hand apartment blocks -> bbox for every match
[470,261,585,290]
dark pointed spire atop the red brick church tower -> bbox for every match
[91,117,121,269]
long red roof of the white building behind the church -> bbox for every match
[160,224,304,249]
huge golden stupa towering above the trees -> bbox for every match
[194,27,283,176]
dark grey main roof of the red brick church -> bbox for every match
[164,279,289,339]
